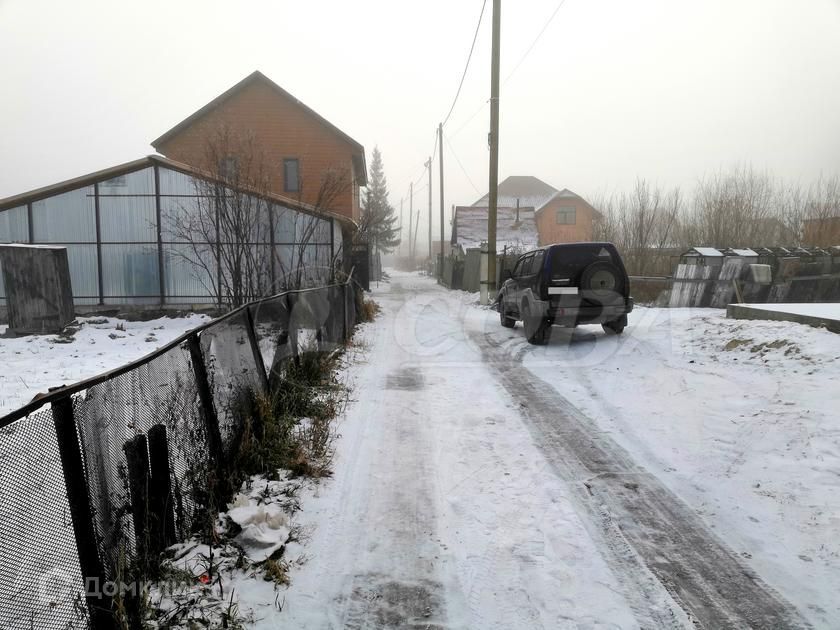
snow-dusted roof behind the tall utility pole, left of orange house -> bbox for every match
[453,206,539,251]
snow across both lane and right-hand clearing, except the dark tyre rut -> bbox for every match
[268,273,840,628]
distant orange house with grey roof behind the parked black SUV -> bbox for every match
[473,175,598,249]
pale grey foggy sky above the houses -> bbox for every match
[0,0,840,244]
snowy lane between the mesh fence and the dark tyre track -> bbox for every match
[270,275,648,629]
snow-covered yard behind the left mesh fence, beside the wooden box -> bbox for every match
[0,315,207,416]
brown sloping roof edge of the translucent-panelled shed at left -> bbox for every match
[0,155,356,226]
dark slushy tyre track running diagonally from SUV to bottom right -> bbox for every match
[473,333,808,629]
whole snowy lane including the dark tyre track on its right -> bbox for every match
[266,274,824,628]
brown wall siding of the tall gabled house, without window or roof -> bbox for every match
[155,82,359,220]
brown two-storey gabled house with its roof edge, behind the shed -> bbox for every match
[152,71,367,221]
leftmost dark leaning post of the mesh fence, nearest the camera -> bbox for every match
[52,396,114,630]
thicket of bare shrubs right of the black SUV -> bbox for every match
[593,165,840,275]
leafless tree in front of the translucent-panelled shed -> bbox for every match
[166,127,350,308]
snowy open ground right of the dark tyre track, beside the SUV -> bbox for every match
[514,308,840,627]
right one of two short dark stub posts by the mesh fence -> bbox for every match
[147,424,175,554]
